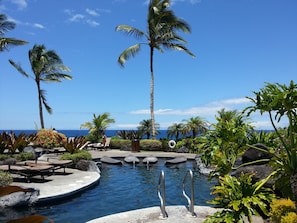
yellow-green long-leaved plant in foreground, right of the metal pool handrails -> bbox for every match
[208,174,274,222]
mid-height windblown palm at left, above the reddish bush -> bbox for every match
[9,45,72,129]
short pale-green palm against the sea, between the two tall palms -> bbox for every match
[80,112,115,142]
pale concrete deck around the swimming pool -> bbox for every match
[13,150,263,223]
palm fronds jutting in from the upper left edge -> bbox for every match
[0,14,28,52]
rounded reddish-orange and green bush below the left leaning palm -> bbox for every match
[33,129,67,149]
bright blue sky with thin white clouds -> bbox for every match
[0,0,297,130]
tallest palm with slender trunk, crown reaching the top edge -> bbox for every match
[115,0,194,139]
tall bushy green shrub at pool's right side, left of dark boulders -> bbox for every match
[199,109,252,176]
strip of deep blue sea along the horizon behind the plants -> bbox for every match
[0,129,167,139]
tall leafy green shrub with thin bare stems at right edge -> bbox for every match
[244,80,297,202]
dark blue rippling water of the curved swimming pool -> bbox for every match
[3,159,215,223]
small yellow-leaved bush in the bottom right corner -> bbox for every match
[269,199,297,223]
